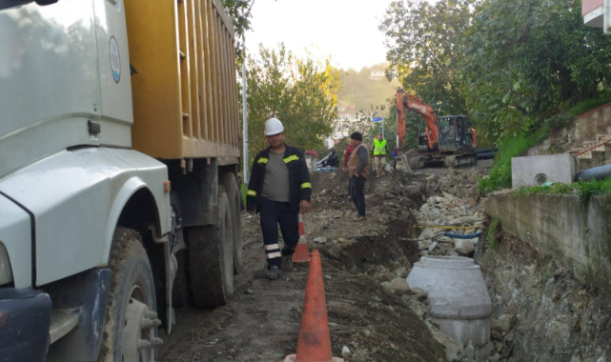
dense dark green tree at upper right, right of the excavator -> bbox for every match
[460,0,611,137]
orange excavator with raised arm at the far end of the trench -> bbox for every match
[396,89,477,168]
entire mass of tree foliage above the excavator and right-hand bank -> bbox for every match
[380,0,611,143]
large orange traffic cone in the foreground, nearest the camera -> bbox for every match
[284,250,344,362]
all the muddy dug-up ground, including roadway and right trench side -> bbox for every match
[160,161,611,362]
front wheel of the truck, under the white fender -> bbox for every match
[98,227,163,362]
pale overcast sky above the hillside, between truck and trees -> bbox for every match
[246,0,392,70]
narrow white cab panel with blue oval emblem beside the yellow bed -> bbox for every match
[93,0,133,147]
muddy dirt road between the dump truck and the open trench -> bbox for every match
[160,168,488,362]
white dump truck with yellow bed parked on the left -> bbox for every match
[0,0,242,362]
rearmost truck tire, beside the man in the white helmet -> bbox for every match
[220,172,243,274]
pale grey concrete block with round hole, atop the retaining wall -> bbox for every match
[511,154,577,190]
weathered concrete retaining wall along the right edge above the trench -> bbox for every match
[484,194,611,291]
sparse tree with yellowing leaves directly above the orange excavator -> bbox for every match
[380,0,474,115]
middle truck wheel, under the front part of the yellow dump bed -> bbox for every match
[187,186,233,308]
